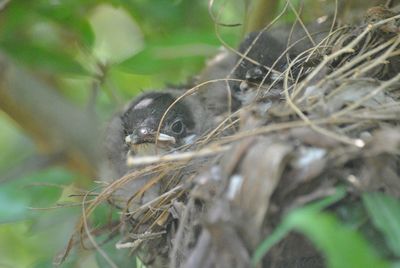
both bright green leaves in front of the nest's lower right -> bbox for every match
[253,189,400,268]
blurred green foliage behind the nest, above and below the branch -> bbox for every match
[0,0,239,267]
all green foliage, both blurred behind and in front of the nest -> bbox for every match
[0,0,400,267]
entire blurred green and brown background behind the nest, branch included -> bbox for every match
[0,0,390,267]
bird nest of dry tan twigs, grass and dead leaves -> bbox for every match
[66,5,400,267]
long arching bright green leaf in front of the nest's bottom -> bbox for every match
[252,189,388,268]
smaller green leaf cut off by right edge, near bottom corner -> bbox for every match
[362,193,400,257]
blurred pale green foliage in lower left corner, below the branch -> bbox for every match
[0,168,79,267]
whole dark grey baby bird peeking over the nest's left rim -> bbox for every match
[101,89,210,207]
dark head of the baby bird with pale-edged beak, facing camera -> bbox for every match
[122,92,195,155]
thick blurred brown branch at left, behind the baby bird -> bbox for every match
[0,54,100,175]
